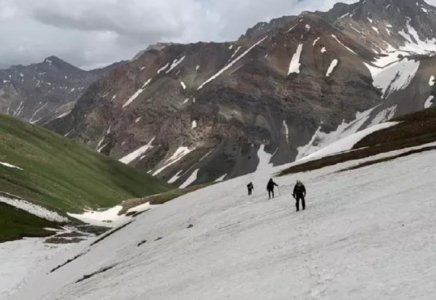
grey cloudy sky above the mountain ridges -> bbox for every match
[0,0,436,69]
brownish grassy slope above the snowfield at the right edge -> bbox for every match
[280,108,436,175]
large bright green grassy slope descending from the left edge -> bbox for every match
[0,115,171,212]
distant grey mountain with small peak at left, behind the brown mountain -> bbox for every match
[0,56,122,124]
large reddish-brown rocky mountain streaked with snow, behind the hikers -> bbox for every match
[46,0,436,187]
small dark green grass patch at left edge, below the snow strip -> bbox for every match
[0,202,56,243]
